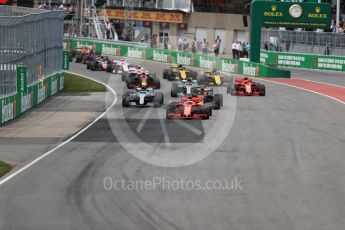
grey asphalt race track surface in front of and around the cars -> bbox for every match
[0,62,345,230]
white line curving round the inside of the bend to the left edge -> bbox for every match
[0,71,117,186]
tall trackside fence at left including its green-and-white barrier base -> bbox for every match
[0,6,65,125]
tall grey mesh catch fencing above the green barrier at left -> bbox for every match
[0,6,65,96]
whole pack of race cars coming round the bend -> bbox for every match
[72,47,266,119]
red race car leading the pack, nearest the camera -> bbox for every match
[166,97,212,120]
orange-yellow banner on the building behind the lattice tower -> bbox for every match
[102,9,183,23]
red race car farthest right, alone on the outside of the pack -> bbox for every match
[226,77,266,96]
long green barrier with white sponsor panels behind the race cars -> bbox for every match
[64,37,290,78]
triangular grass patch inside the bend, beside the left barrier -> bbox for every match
[62,72,107,93]
